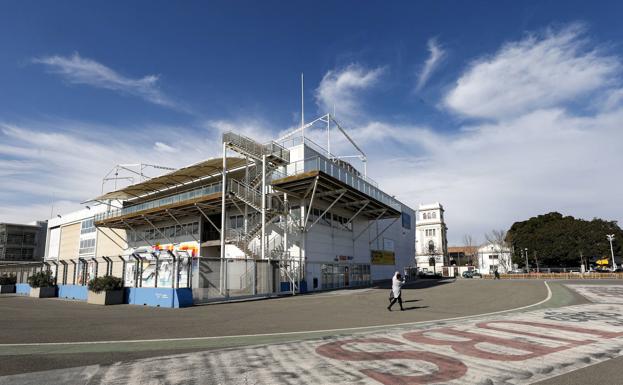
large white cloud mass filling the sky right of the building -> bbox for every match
[310,25,623,244]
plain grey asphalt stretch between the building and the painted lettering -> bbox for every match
[0,279,548,375]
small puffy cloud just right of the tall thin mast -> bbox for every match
[315,64,385,121]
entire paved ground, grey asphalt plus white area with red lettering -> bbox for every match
[0,280,623,385]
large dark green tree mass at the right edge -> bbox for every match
[506,212,623,267]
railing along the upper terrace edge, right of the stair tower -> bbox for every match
[287,156,402,210]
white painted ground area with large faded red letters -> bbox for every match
[7,286,623,385]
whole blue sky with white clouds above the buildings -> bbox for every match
[0,1,623,245]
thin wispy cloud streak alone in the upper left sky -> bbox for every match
[33,53,186,110]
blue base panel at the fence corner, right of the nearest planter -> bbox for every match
[125,287,193,308]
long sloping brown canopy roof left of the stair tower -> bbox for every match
[92,157,248,201]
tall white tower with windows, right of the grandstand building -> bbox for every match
[415,202,448,272]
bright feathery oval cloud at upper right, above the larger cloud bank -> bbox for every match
[444,24,621,119]
